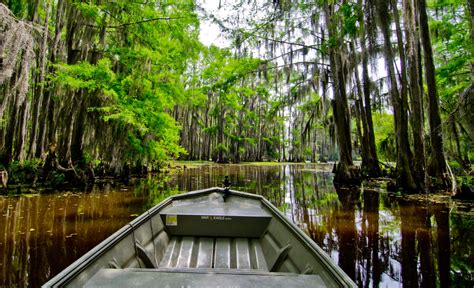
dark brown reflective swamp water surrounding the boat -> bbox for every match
[0,164,474,287]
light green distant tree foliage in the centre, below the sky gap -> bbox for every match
[192,46,275,161]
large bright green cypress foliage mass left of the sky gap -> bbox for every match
[46,0,205,170]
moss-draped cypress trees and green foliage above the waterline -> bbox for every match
[0,0,474,193]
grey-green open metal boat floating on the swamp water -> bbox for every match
[43,188,356,288]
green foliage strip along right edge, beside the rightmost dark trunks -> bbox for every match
[429,0,474,171]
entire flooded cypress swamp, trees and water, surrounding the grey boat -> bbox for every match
[0,0,474,288]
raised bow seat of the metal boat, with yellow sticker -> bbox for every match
[160,193,272,238]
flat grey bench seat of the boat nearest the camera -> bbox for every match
[84,269,326,288]
